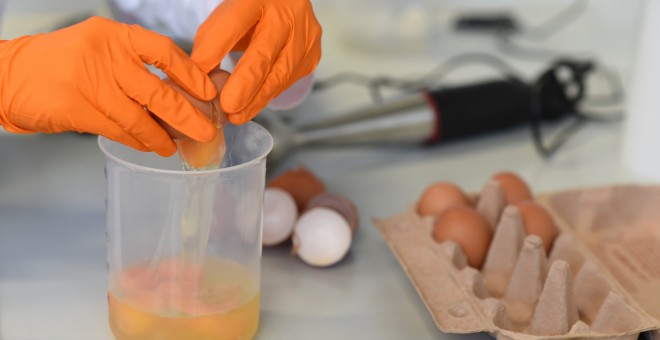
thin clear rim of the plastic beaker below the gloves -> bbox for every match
[98,121,273,176]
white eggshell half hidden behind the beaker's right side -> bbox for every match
[261,188,298,246]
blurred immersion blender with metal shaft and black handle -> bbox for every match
[256,60,582,167]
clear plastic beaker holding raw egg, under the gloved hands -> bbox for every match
[99,122,273,340]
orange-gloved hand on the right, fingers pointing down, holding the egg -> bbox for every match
[191,0,321,124]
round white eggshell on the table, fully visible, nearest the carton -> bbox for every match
[293,207,352,267]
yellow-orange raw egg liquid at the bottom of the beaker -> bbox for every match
[108,260,259,340]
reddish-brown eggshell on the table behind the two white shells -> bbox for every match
[268,166,325,211]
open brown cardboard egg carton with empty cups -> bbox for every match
[374,182,660,339]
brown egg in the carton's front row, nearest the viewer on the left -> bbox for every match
[433,206,493,269]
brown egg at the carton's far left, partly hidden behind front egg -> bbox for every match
[417,182,470,217]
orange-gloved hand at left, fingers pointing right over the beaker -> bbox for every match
[0,17,217,156]
